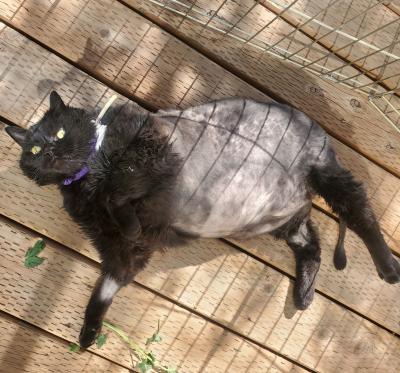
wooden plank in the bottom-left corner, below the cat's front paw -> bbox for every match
[0,314,129,373]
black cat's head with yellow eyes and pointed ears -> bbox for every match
[6,91,95,185]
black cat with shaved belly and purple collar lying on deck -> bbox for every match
[6,91,400,347]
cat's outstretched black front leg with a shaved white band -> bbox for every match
[79,244,151,348]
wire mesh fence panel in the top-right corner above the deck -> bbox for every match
[145,0,400,131]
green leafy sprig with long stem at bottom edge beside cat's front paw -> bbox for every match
[103,321,178,373]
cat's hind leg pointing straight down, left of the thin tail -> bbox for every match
[286,217,321,310]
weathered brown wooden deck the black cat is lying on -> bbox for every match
[0,0,400,373]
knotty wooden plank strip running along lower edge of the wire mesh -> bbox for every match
[123,0,400,176]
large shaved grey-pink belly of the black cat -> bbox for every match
[152,99,326,237]
